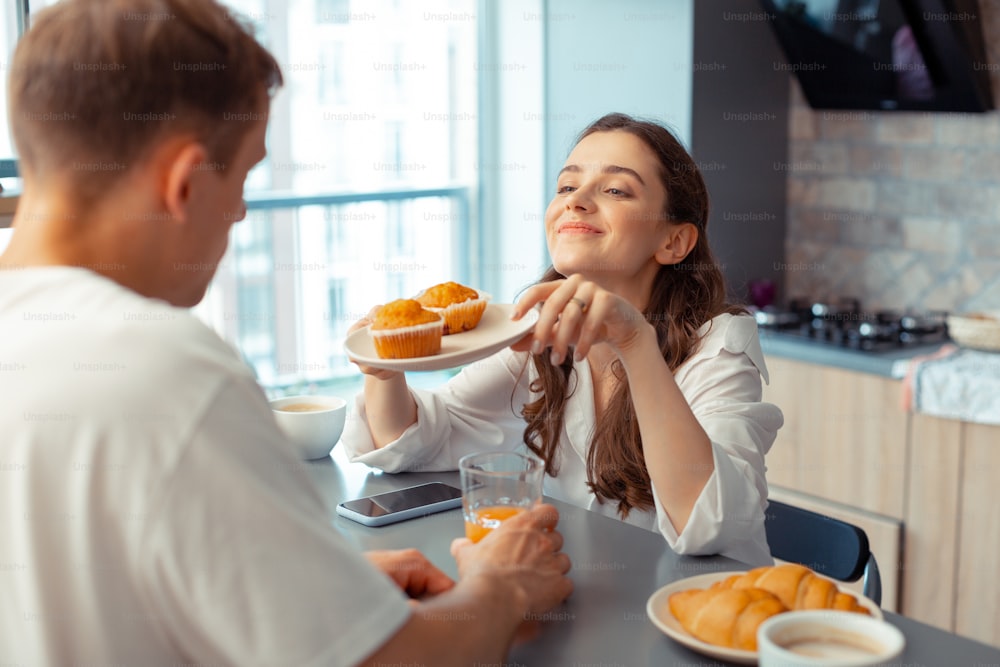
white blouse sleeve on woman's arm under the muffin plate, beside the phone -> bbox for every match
[341,348,530,472]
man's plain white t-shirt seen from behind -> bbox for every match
[0,267,410,666]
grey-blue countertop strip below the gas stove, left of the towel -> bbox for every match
[760,329,943,380]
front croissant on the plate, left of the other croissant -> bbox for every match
[668,588,788,651]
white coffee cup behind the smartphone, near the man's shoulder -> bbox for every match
[271,396,347,460]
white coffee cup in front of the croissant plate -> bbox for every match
[757,610,906,667]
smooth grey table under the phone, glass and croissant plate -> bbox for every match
[303,446,1000,667]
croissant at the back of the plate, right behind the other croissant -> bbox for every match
[712,563,869,614]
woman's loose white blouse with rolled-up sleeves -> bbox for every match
[341,314,783,565]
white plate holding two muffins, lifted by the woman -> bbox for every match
[344,303,538,371]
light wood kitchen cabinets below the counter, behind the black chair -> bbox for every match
[764,356,1000,645]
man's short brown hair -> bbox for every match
[9,0,282,201]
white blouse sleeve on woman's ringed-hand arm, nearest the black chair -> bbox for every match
[653,316,784,564]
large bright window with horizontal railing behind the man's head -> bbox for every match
[0,0,545,394]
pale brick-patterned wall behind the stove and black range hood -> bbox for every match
[783,1,1000,312]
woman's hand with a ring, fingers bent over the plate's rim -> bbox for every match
[512,275,650,365]
